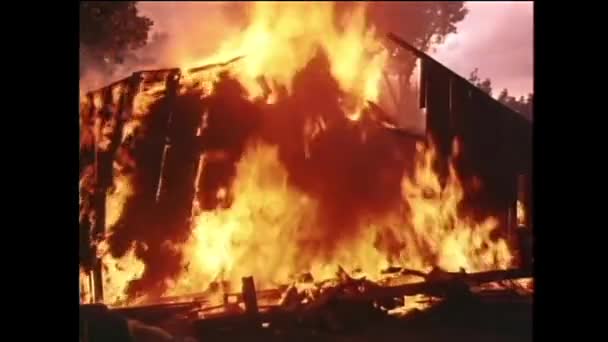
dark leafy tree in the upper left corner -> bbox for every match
[80,1,153,76]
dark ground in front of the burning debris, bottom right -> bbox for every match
[188,296,532,342]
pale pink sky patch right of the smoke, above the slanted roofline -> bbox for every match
[432,1,534,96]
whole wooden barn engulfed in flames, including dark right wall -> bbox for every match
[80,3,531,342]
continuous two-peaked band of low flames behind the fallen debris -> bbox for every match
[169,139,512,295]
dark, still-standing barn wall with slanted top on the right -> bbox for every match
[420,59,531,235]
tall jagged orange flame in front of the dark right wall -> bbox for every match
[403,140,512,272]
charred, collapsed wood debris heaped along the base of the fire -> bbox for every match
[81,268,529,337]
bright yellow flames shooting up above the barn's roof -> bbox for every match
[182,1,388,119]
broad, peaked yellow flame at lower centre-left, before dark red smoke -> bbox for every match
[169,146,316,295]
